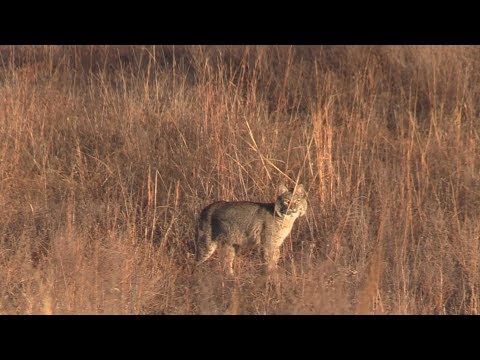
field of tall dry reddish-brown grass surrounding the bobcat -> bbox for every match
[0,46,480,314]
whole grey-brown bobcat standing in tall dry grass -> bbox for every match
[196,185,307,275]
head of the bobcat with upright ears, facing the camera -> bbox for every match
[275,184,307,217]
